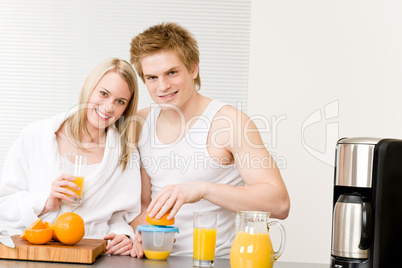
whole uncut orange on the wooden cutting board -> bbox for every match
[53,212,85,246]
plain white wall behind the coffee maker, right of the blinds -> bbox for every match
[248,0,402,263]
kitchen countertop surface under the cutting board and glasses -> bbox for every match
[0,255,329,268]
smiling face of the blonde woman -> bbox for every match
[86,71,131,132]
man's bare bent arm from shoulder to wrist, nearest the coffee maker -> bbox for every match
[203,107,290,219]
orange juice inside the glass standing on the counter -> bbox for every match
[193,228,217,261]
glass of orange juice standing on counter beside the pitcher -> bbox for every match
[193,212,219,267]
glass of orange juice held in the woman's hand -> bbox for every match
[62,153,87,204]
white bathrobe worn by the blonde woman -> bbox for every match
[0,113,141,239]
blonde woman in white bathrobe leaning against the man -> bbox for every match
[0,58,141,255]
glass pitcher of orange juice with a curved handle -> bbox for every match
[230,211,286,268]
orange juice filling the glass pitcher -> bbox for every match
[230,232,274,268]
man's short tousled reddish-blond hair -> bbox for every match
[130,22,201,89]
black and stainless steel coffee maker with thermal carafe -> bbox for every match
[331,138,402,268]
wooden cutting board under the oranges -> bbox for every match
[0,235,106,263]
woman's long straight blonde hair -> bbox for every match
[66,58,138,170]
